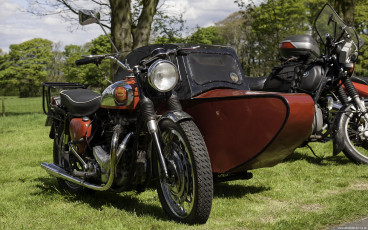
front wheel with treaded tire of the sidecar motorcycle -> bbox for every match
[154,119,213,224]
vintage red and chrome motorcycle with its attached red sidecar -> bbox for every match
[41,6,314,224]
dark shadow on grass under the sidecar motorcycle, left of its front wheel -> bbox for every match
[33,178,169,221]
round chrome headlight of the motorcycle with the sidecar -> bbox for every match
[148,60,179,92]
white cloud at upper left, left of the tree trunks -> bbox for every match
[0,0,103,52]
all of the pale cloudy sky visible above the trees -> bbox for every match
[0,0,247,52]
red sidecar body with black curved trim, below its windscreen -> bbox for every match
[182,89,314,173]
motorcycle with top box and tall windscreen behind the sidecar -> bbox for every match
[250,4,368,163]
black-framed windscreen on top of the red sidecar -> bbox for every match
[176,46,249,99]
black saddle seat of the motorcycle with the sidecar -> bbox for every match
[60,89,101,117]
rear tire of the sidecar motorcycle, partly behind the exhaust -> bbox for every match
[53,124,85,193]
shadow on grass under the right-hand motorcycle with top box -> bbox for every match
[284,151,352,166]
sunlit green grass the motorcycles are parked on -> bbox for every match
[0,98,368,230]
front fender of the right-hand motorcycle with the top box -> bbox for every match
[333,103,353,156]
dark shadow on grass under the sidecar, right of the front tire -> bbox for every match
[213,183,271,198]
